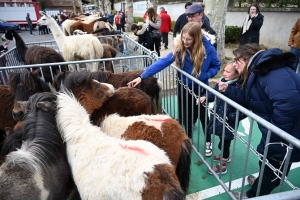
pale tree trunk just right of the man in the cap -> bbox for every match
[205,0,228,60]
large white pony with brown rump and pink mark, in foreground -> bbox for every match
[56,87,185,200]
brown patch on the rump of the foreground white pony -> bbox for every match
[142,164,185,200]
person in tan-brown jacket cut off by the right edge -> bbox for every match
[288,18,300,75]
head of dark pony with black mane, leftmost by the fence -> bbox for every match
[8,69,51,121]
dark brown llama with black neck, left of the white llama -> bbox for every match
[2,29,68,82]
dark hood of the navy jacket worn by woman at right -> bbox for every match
[248,48,296,75]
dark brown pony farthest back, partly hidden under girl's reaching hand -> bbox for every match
[92,70,162,114]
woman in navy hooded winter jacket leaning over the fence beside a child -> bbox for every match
[219,44,300,198]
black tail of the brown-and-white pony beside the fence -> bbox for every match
[176,138,192,193]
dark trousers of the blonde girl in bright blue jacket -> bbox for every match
[177,84,211,142]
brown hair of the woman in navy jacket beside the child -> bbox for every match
[232,43,261,86]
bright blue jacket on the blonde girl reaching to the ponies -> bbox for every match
[141,36,221,88]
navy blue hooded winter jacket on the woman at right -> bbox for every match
[224,48,300,162]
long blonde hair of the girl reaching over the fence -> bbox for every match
[174,22,205,78]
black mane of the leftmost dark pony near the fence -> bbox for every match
[8,71,51,92]
